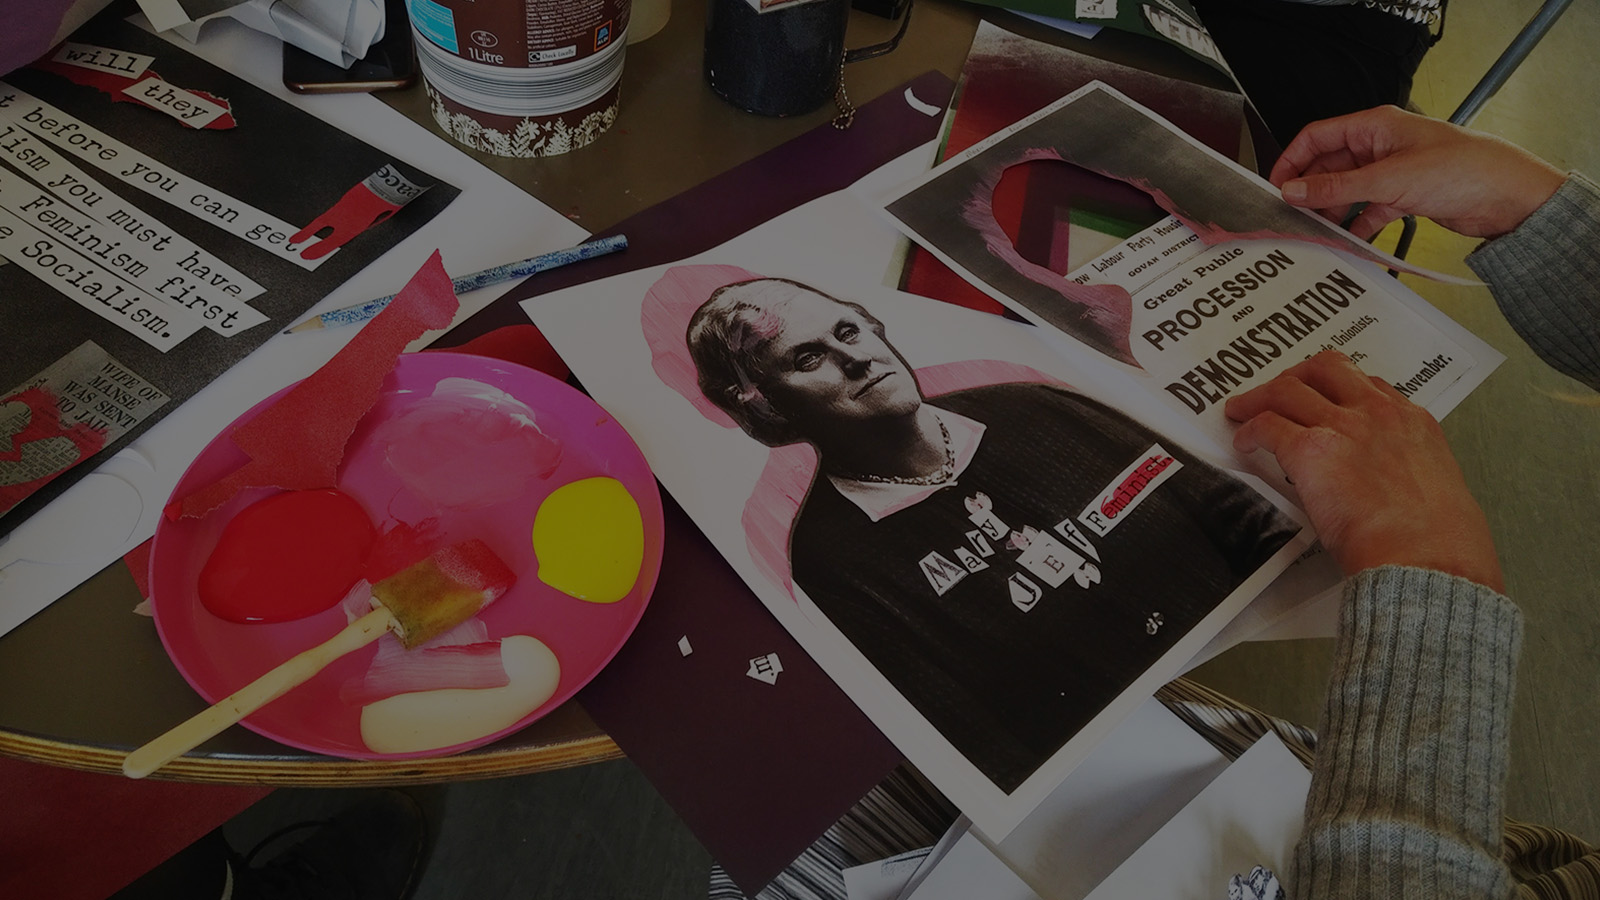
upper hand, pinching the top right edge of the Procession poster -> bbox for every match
[1267,106,1566,240]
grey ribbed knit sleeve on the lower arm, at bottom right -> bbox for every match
[1290,565,1522,900]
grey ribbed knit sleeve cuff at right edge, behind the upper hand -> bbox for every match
[1467,173,1600,391]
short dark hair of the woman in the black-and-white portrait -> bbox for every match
[686,279,883,447]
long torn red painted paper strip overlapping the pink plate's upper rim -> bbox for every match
[176,250,461,517]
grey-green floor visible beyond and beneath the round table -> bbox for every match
[152,0,1600,900]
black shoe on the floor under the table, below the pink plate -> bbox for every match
[234,790,427,900]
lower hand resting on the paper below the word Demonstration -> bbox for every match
[1226,351,1504,591]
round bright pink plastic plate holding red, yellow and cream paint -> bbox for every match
[150,352,662,759]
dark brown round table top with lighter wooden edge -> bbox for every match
[0,0,1221,786]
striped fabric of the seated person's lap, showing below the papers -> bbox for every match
[710,679,1600,900]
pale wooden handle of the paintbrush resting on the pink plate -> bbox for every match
[122,607,394,778]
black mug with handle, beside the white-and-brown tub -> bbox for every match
[706,0,910,115]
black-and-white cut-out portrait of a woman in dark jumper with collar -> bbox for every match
[685,277,1299,793]
